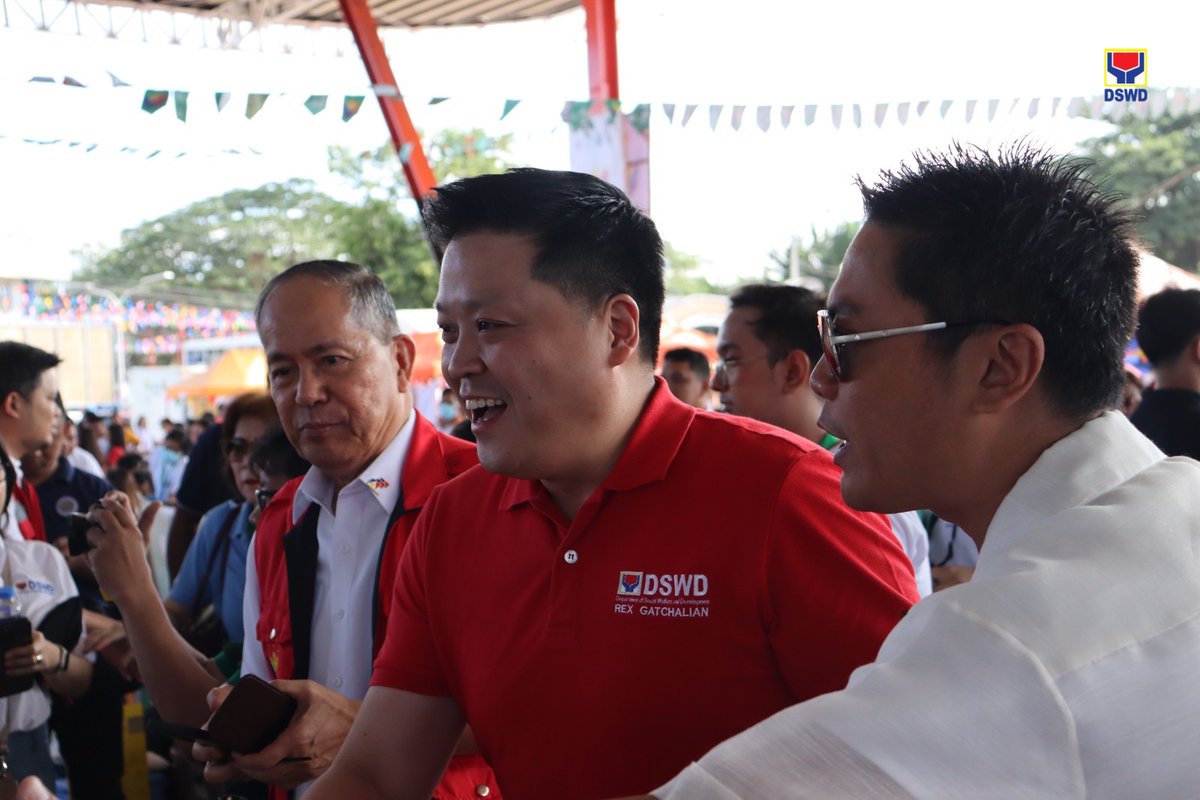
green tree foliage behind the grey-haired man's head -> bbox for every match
[76,131,511,308]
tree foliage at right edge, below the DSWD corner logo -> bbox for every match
[1082,113,1200,272]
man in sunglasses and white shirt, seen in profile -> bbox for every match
[624,145,1200,800]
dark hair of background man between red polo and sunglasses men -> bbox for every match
[730,283,826,366]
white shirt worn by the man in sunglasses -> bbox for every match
[655,411,1200,800]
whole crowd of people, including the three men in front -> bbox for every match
[0,145,1200,800]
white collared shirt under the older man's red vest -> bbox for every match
[241,414,416,796]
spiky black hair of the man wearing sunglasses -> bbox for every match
[859,144,1138,420]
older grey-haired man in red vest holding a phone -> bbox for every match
[197,261,499,800]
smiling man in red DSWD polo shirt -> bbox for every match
[311,169,917,800]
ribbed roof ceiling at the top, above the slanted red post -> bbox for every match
[123,0,580,28]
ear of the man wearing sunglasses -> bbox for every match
[962,323,1045,414]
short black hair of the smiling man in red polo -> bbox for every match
[422,168,665,365]
